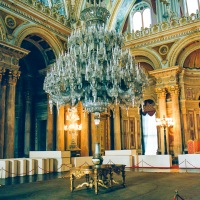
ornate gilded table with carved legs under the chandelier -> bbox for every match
[70,164,125,194]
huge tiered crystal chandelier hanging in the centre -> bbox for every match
[44,0,147,121]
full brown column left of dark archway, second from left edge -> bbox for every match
[4,71,17,158]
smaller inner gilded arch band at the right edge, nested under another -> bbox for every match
[178,42,200,67]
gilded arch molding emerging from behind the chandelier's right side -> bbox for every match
[130,49,161,69]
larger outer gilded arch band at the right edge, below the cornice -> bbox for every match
[168,32,200,67]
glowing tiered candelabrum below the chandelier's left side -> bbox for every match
[64,107,82,149]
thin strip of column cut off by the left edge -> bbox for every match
[0,71,6,159]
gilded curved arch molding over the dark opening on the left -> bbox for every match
[14,25,64,56]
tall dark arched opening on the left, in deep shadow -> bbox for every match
[15,34,55,157]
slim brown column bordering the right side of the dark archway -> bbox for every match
[46,98,54,151]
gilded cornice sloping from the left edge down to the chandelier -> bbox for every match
[0,0,71,38]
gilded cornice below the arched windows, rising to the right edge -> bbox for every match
[125,14,200,48]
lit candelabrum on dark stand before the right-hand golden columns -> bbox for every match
[156,115,174,155]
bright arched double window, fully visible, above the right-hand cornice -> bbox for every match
[130,2,151,31]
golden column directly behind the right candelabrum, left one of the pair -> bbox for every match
[156,88,168,154]
